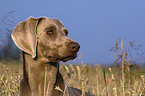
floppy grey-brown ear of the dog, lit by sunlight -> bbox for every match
[11,17,42,58]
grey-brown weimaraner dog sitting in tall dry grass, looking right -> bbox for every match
[11,17,93,96]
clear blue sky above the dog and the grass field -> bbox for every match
[0,0,145,64]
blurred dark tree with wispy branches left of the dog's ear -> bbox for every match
[0,11,20,60]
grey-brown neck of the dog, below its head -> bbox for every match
[22,52,65,96]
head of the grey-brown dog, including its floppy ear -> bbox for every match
[11,17,80,62]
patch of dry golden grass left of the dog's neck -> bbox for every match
[0,61,22,96]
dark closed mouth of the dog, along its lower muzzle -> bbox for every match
[48,55,77,62]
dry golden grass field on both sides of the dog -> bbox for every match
[0,39,145,96]
